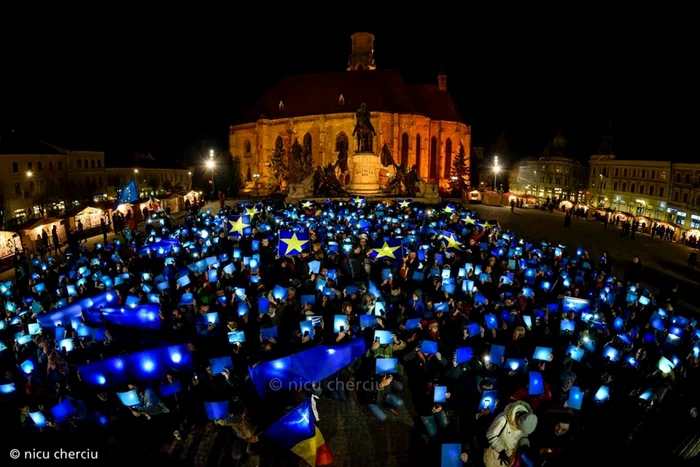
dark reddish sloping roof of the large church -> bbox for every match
[238,70,463,124]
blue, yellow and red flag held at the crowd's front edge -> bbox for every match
[265,398,333,467]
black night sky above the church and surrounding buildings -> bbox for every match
[0,12,697,167]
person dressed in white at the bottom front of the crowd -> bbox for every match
[484,401,537,467]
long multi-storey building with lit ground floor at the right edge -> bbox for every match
[589,155,700,230]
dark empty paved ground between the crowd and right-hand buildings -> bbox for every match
[469,204,700,312]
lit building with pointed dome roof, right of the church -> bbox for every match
[509,134,589,203]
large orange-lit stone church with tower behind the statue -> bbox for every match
[229,33,471,191]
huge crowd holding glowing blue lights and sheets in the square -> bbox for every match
[0,198,700,467]
